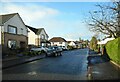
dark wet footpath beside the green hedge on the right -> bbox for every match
[87,50,120,82]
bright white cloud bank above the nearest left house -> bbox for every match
[2,3,60,24]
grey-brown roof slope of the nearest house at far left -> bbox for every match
[0,13,18,25]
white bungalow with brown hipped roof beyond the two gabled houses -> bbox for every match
[49,37,67,49]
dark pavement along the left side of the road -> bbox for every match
[2,54,45,69]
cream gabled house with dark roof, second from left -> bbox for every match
[26,25,50,46]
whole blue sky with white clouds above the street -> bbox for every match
[0,2,112,41]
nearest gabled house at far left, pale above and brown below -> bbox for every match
[0,13,28,52]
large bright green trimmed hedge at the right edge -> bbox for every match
[105,37,120,65]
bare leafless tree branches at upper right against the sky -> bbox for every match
[87,1,120,38]
